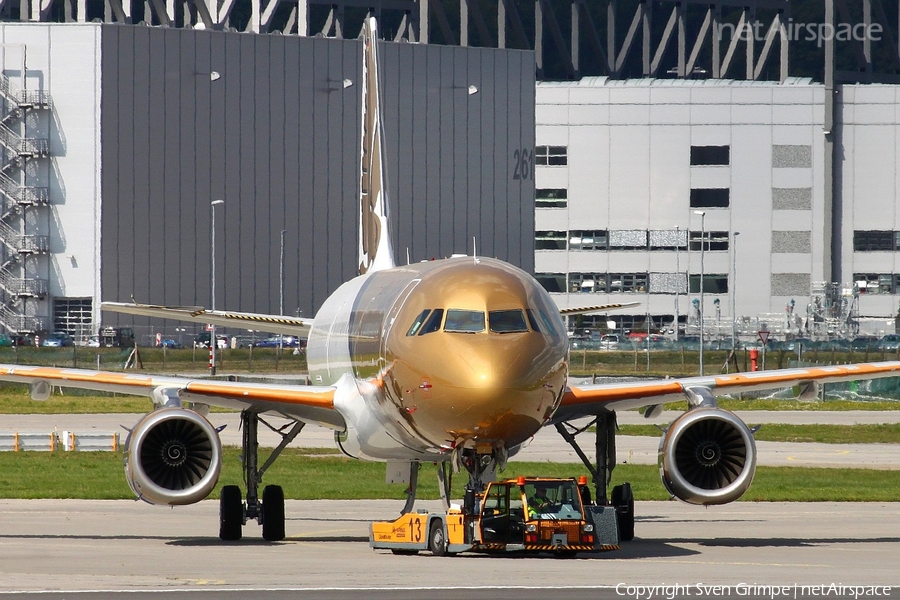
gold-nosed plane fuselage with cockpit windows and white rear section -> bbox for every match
[307,257,568,458]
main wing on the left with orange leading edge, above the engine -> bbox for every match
[0,365,345,431]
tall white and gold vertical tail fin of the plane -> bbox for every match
[359,17,396,275]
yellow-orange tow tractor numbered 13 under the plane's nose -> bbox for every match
[369,477,619,556]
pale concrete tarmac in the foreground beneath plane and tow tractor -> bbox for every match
[0,500,900,599]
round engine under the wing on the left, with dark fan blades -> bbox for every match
[125,408,222,505]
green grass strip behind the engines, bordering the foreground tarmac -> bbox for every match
[0,448,900,502]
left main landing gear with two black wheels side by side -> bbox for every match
[219,410,305,542]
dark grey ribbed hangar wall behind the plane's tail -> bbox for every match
[100,25,535,325]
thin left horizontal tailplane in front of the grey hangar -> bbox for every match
[100,302,313,337]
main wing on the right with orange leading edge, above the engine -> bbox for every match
[553,361,900,422]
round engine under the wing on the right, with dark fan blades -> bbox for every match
[659,407,756,505]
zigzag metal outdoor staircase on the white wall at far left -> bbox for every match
[0,75,52,335]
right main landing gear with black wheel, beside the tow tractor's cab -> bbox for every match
[556,412,634,542]
